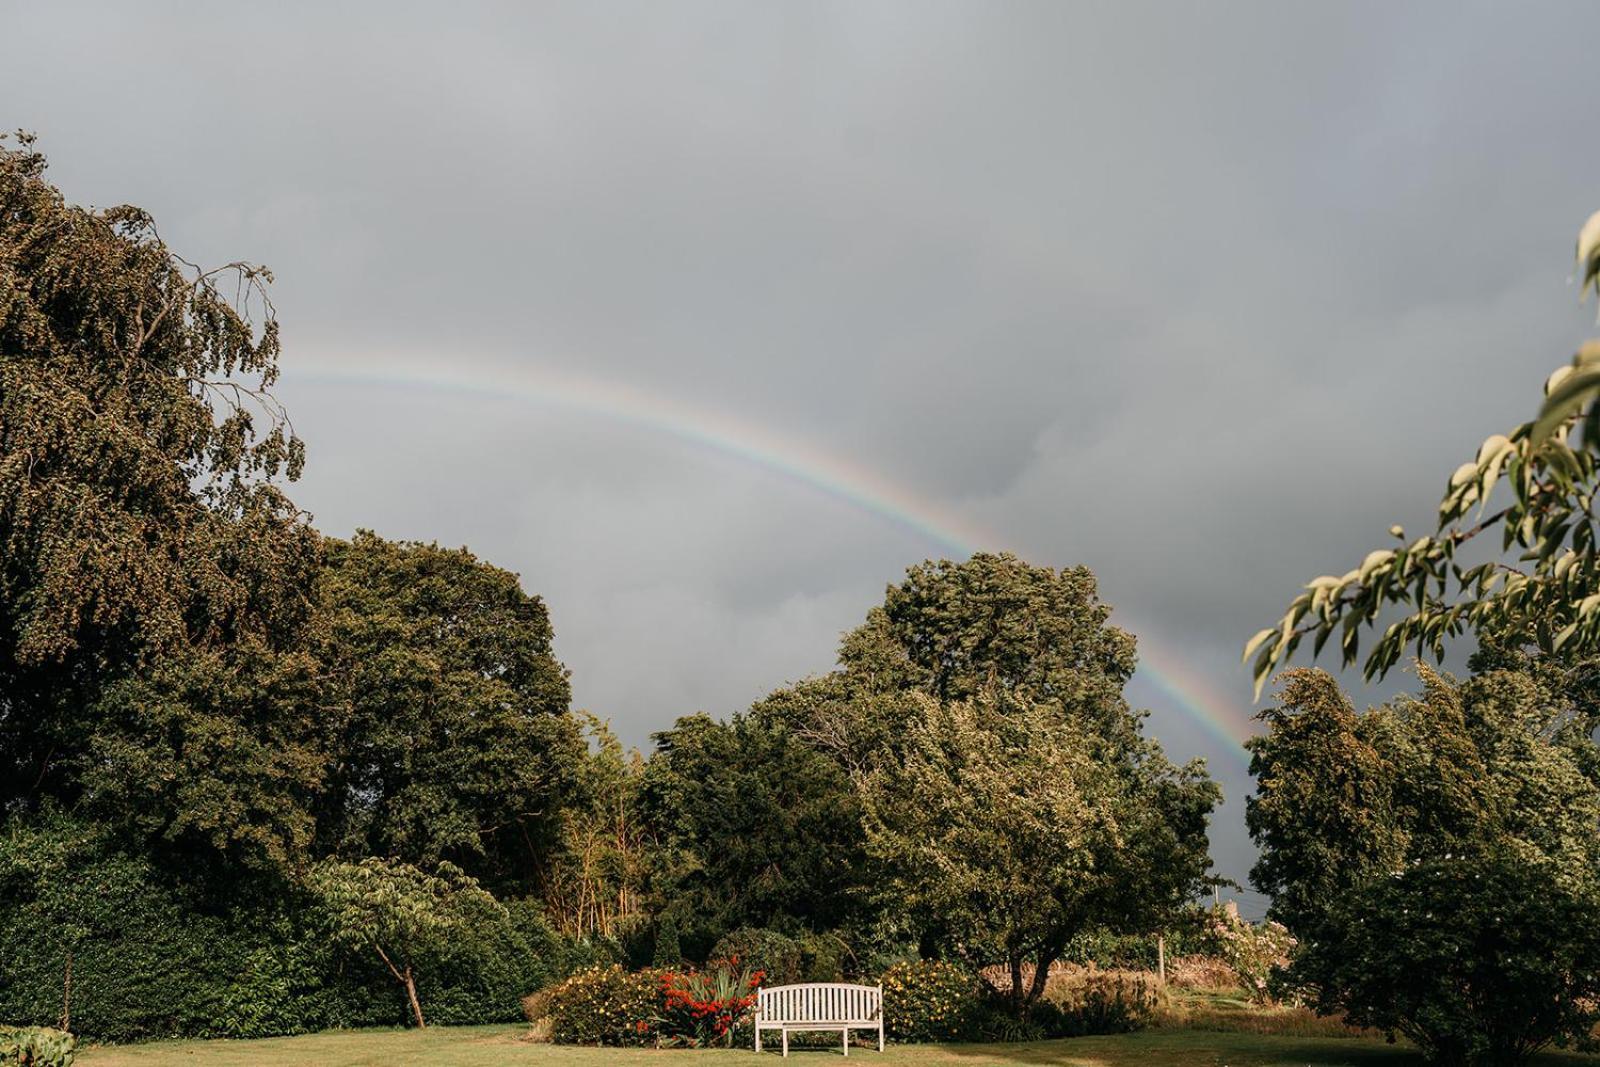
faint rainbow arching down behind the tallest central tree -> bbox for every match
[293,357,1250,765]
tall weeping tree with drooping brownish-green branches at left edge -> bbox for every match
[0,138,317,859]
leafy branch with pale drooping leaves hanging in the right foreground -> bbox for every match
[1243,211,1600,696]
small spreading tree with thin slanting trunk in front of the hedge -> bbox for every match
[312,857,506,1029]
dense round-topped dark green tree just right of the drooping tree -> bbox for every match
[315,531,582,889]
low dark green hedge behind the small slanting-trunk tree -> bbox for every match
[0,821,588,1041]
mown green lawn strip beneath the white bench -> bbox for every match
[78,1025,1600,1067]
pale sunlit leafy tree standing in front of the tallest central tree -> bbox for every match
[861,696,1218,1014]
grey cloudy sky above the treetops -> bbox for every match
[12,0,1600,895]
